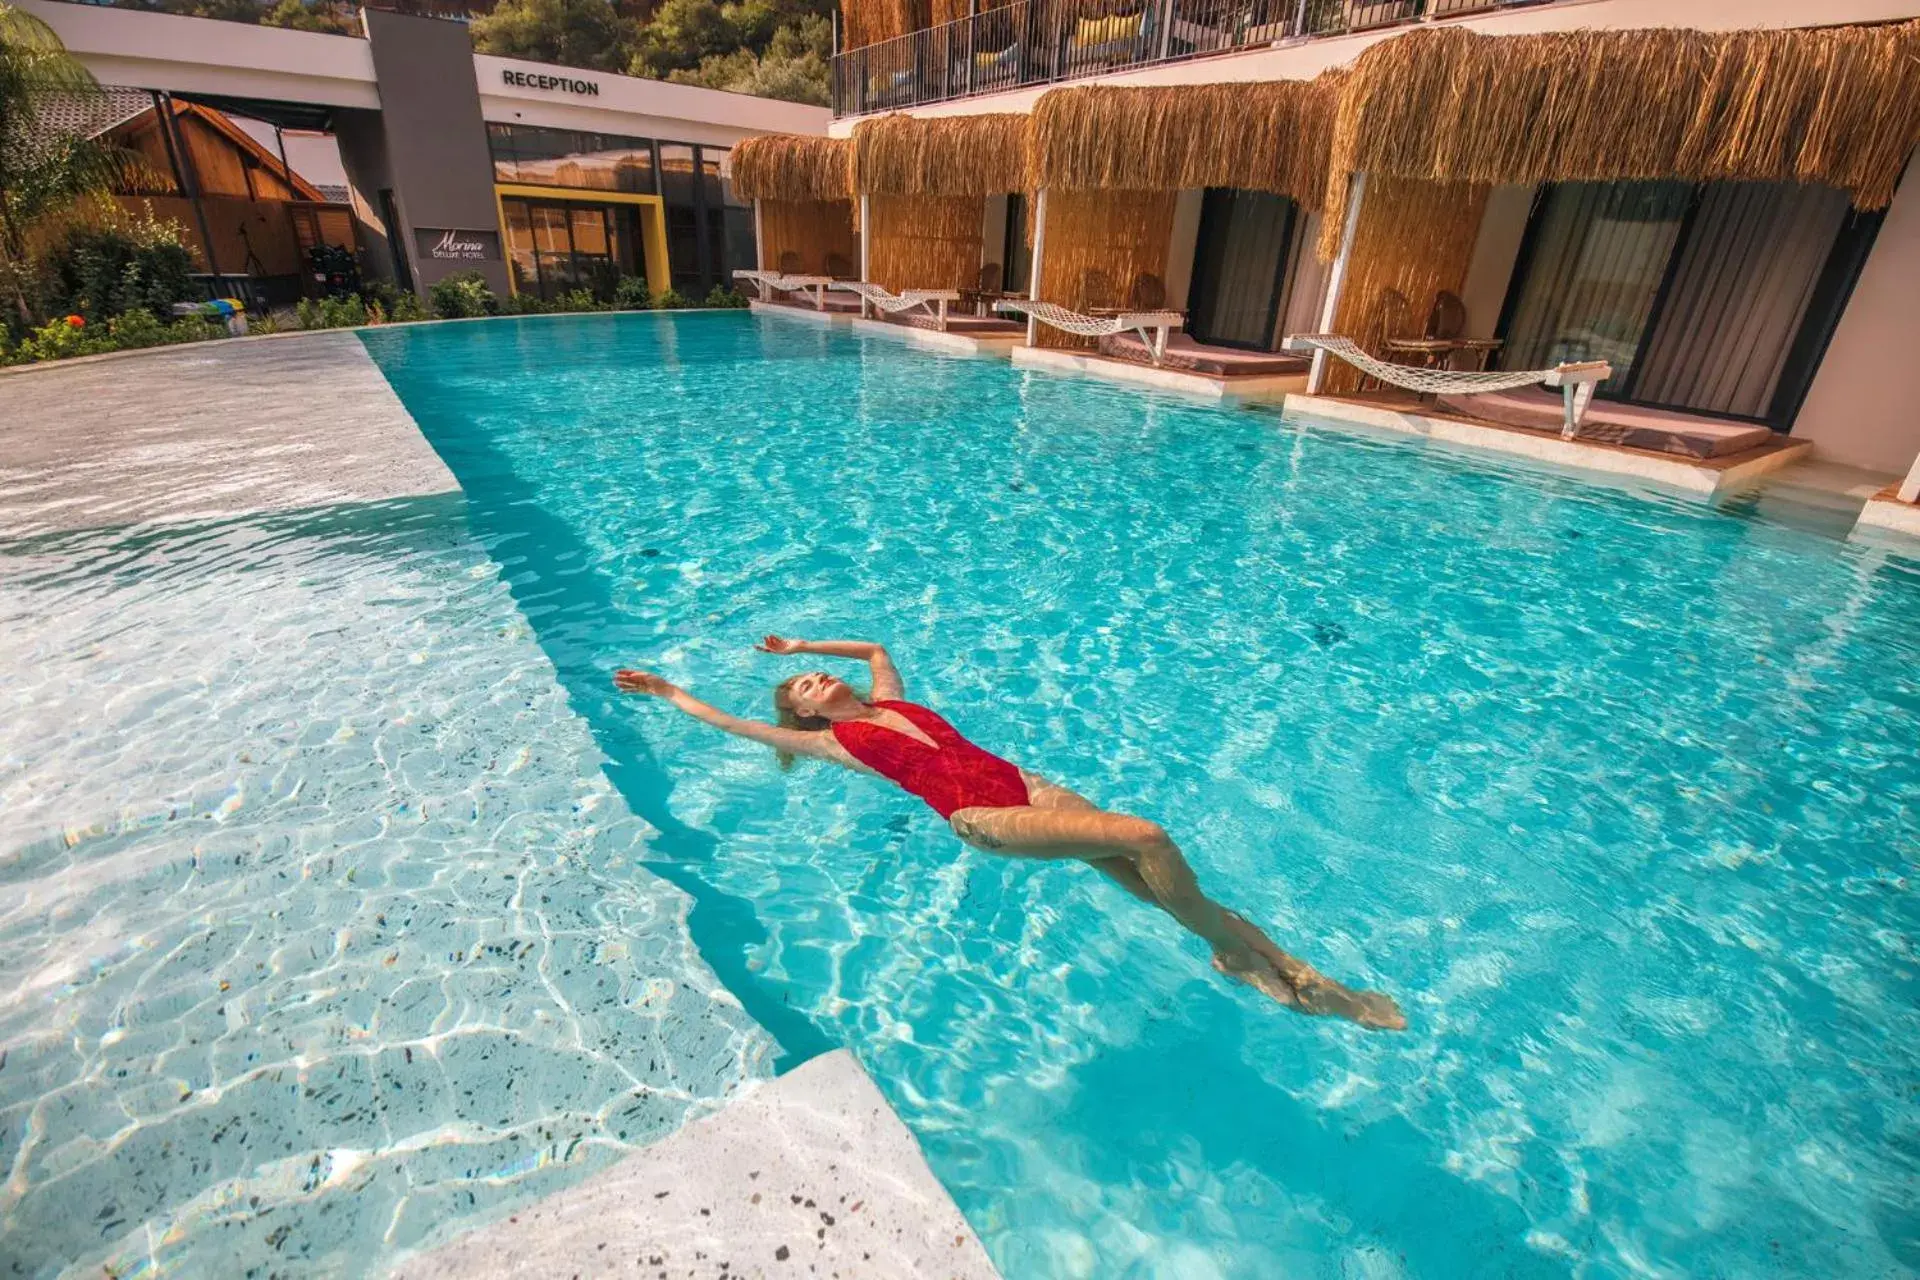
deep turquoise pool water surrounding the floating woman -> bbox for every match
[353,315,1920,1280]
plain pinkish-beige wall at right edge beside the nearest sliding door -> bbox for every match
[1793,155,1920,472]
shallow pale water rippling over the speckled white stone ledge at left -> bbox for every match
[0,495,772,1280]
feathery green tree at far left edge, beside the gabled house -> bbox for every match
[0,0,136,272]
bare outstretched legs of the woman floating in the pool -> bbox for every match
[952,802,1405,1029]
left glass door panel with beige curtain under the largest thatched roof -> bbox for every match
[1503,182,1693,385]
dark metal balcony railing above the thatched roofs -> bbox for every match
[833,0,1549,115]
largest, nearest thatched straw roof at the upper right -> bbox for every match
[1321,23,1920,253]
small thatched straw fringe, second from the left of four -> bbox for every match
[852,115,1027,196]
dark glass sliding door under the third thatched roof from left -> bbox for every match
[1187,186,1296,351]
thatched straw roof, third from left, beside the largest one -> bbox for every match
[1033,71,1346,209]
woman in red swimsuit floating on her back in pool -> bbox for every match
[612,635,1407,1031]
